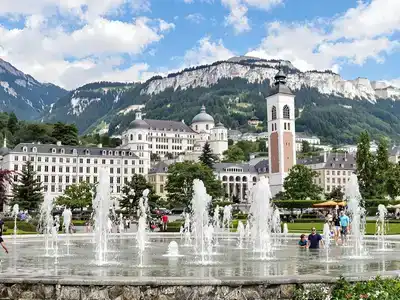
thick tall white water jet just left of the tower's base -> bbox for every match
[249,177,273,260]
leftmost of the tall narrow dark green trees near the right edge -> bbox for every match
[356,131,376,199]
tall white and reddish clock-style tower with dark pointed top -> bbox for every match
[267,69,296,196]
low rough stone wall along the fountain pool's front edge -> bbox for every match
[0,280,331,300]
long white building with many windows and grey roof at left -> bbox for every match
[0,142,143,204]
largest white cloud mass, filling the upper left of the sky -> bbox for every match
[0,0,175,89]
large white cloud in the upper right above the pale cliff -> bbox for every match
[247,0,400,72]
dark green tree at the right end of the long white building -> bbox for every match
[119,174,160,212]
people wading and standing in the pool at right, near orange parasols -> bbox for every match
[298,211,350,249]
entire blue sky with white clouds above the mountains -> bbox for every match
[0,0,400,89]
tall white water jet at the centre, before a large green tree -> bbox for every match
[192,179,211,265]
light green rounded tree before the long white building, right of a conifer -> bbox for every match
[56,181,95,210]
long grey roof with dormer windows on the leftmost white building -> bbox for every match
[10,143,139,159]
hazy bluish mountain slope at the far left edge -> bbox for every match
[0,58,67,120]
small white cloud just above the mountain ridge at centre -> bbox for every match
[182,37,234,67]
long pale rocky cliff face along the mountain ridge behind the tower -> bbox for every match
[144,58,400,102]
